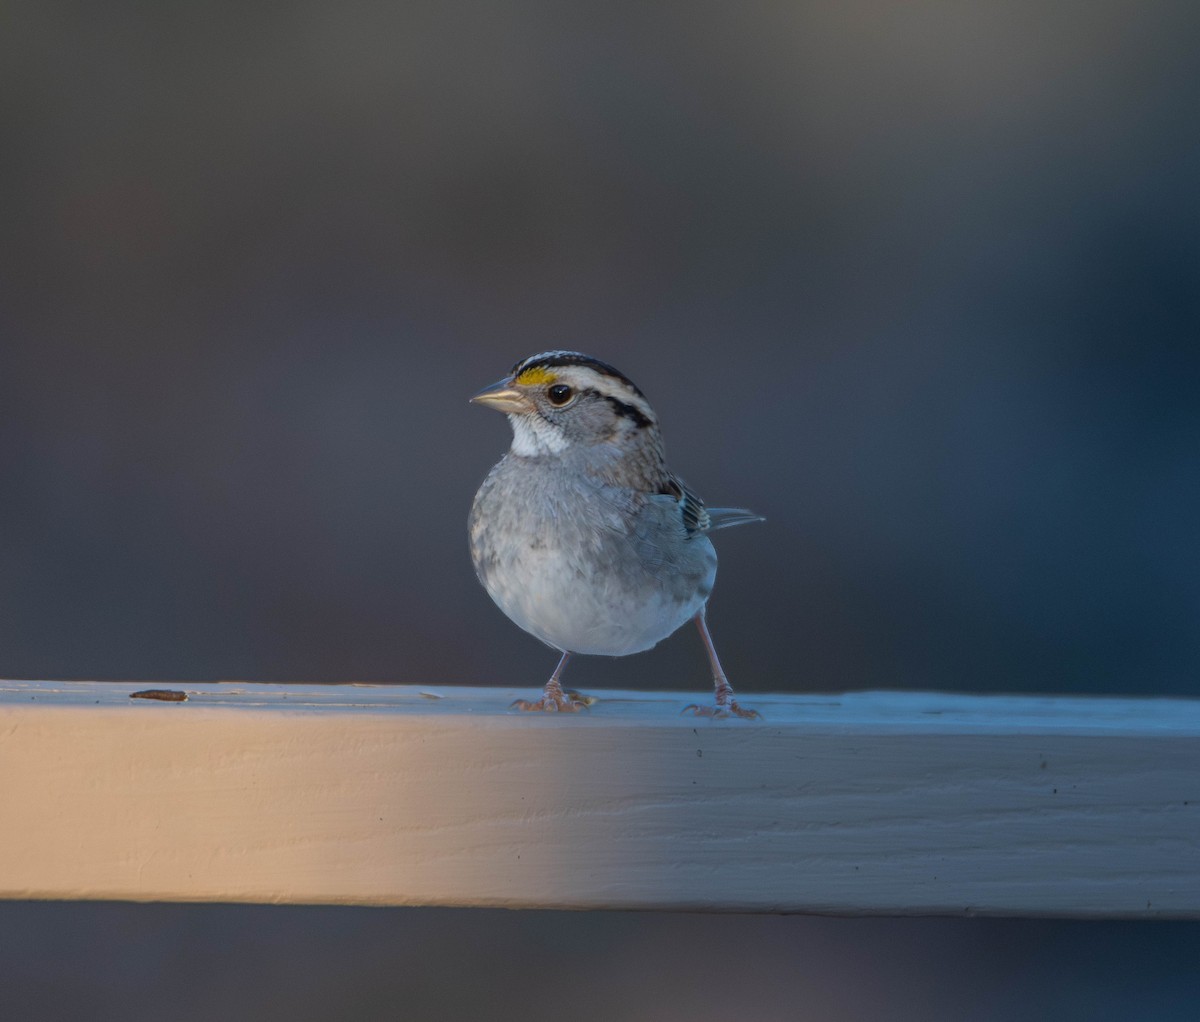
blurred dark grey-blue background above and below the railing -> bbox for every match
[0,0,1200,1020]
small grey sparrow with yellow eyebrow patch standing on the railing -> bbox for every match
[469,350,763,719]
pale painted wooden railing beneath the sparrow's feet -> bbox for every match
[0,681,1200,918]
